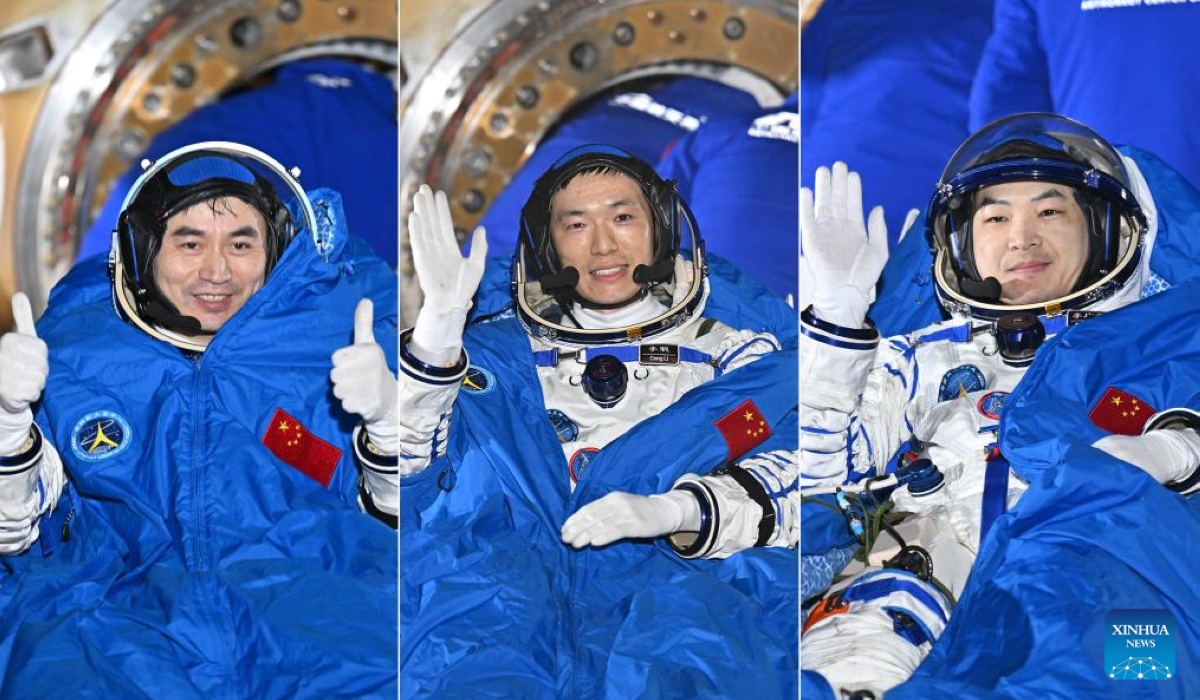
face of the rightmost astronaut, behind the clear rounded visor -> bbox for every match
[971,181,1087,304]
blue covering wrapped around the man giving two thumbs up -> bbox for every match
[0,191,397,699]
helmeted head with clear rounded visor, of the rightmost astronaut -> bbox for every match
[926,114,1146,319]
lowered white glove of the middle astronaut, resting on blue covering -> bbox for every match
[563,490,700,549]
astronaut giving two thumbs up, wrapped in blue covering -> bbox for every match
[0,142,397,696]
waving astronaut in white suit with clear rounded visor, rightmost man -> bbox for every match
[800,114,1200,698]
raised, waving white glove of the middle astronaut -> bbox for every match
[408,185,487,367]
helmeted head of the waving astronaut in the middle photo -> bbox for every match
[512,145,707,345]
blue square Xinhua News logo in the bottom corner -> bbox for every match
[1104,610,1176,681]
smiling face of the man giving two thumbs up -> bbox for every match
[154,197,266,337]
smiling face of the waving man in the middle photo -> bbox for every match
[550,172,654,304]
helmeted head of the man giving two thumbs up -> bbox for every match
[110,142,304,352]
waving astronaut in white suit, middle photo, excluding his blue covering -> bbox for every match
[400,145,797,557]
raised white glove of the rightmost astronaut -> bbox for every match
[800,161,888,329]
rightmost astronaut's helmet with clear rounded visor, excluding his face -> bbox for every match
[925,113,1146,319]
